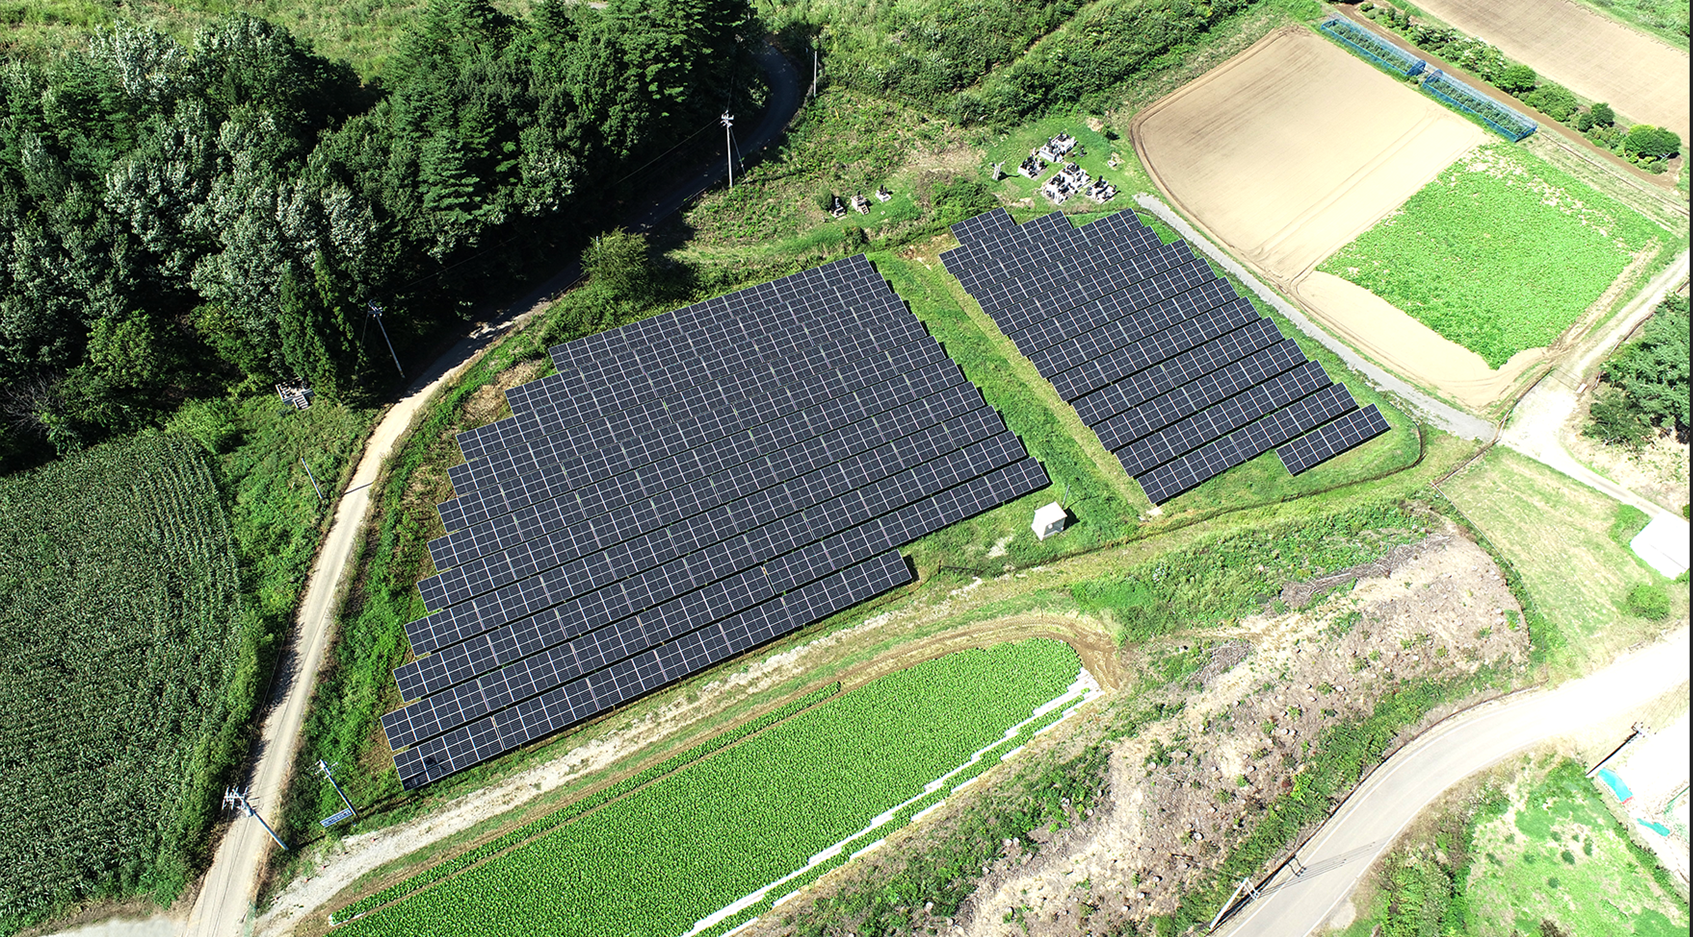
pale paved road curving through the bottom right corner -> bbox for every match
[1217,627,1688,937]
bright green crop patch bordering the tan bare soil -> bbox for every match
[1321,144,1669,368]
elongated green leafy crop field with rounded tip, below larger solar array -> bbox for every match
[337,639,1077,937]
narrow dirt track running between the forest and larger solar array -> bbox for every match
[175,44,799,937]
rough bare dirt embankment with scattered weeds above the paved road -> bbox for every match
[951,532,1527,937]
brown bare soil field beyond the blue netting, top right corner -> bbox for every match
[1417,0,1688,141]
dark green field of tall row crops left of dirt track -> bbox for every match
[0,435,256,934]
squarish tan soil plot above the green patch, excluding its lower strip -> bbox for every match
[1134,27,1483,281]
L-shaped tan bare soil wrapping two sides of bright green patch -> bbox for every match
[1131,27,1542,410]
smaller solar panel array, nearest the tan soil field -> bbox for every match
[941,208,1388,503]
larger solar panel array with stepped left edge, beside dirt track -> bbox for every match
[383,256,1048,788]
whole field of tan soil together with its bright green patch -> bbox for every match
[1131,20,1673,412]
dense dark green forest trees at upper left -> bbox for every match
[0,0,750,459]
